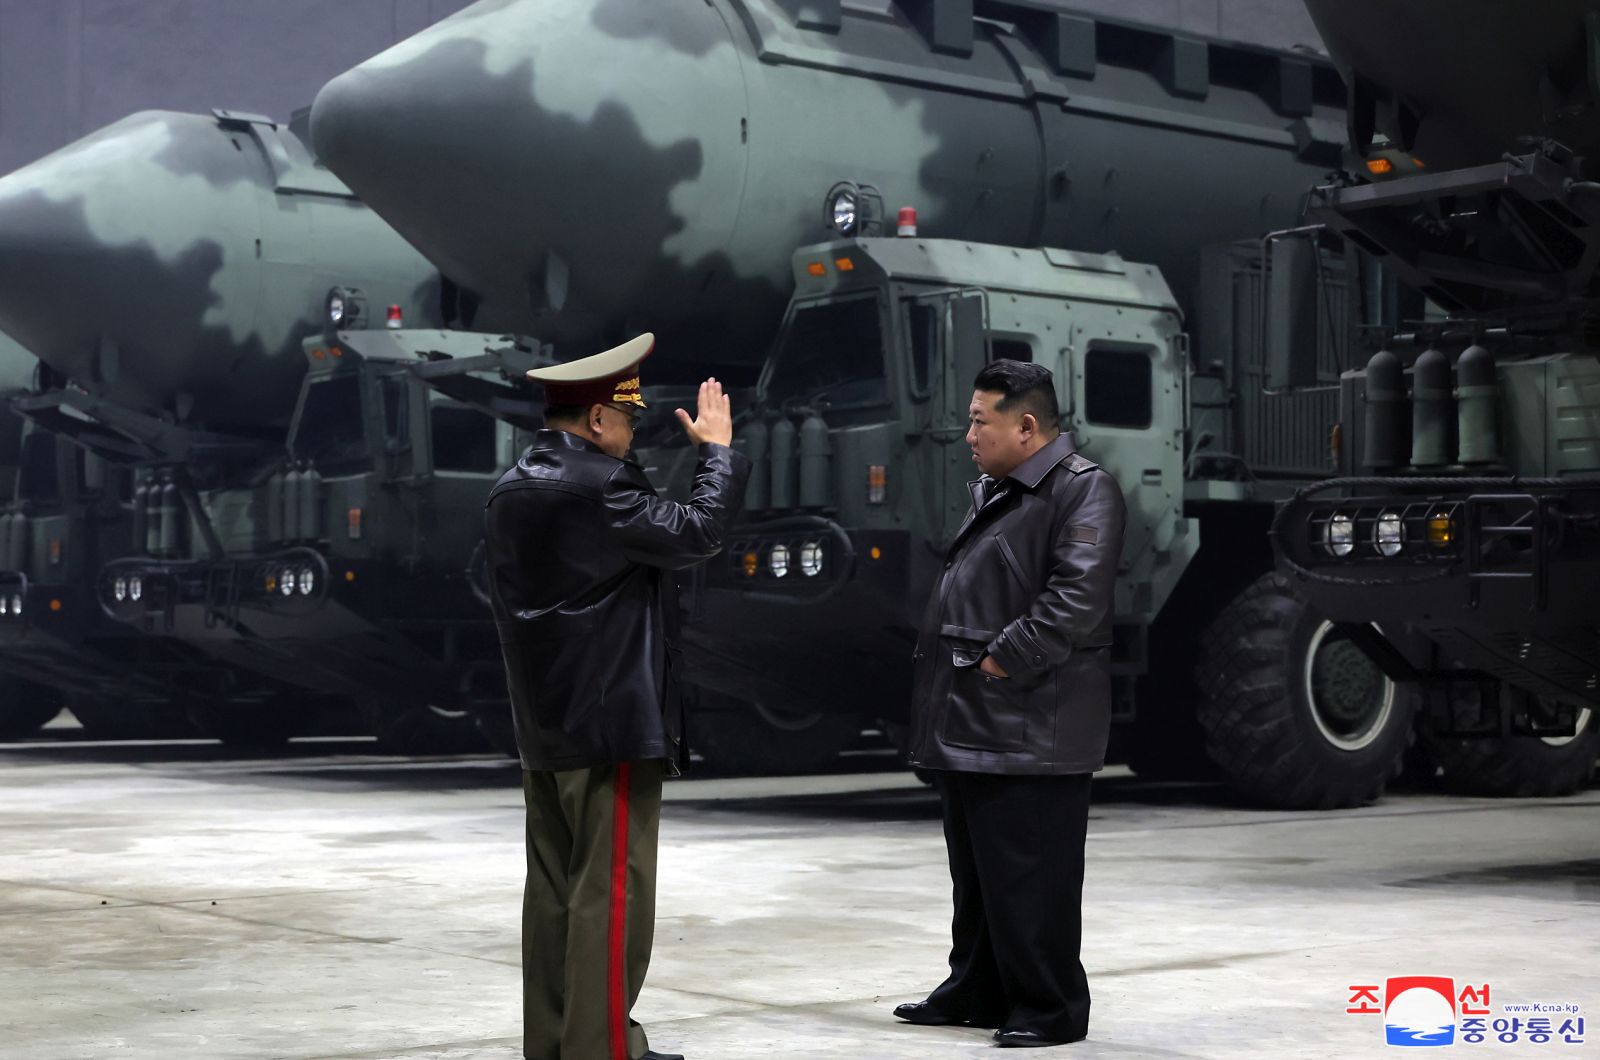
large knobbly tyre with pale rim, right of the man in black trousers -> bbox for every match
[1195,573,1414,810]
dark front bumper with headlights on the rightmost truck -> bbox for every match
[1272,479,1600,706]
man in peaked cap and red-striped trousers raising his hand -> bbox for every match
[485,335,749,1060]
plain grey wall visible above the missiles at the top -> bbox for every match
[0,0,1317,173]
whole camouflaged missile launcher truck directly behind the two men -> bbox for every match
[302,0,1472,805]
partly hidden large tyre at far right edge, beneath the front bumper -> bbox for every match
[1424,689,1600,797]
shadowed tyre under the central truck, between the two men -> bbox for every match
[690,693,861,777]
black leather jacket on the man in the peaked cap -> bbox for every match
[485,431,749,770]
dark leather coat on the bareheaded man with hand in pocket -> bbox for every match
[910,432,1126,773]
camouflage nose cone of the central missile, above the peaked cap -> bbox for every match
[312,0,755,341]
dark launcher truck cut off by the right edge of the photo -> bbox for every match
[1275,0,1600,794]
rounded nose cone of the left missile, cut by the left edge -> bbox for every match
[0,114,256,400]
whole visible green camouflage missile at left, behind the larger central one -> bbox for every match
[0,112,438,432]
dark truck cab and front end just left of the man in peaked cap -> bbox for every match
[99,333,515,753]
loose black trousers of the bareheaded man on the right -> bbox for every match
[928,772,1090,1041]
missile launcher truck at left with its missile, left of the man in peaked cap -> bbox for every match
[0,112,524,749]
